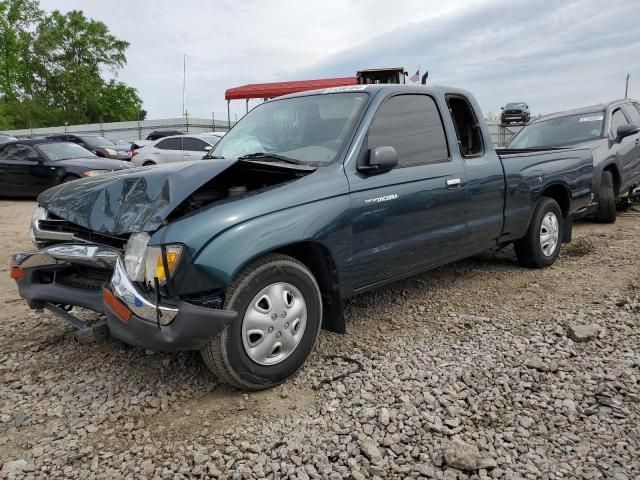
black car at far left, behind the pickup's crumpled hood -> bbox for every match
[0,140,131,197]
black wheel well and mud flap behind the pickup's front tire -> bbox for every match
[274,242,346,333]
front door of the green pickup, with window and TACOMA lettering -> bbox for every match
[347,94,468,290]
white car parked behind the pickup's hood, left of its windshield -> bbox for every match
[131,132,225,167]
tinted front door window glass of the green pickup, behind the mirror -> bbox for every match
[367,95,450,168]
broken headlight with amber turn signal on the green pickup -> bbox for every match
[124,233,182,286]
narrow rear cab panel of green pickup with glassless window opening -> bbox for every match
[446,94,505,251]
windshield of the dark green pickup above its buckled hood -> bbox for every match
[211,92,367,164]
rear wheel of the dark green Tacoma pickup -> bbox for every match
[514,198,563,268]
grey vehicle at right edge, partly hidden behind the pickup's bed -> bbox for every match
[507,99,640,223]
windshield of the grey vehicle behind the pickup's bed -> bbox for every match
[507,112,604,149]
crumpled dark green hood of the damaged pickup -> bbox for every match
[38,160,236,235]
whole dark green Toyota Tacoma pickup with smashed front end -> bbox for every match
[11,85,592,390]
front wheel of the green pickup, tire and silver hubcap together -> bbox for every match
[200,254,322,390]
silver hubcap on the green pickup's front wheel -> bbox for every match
[242,282,307,365]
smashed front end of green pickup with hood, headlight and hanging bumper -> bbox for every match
[11,161,313,351]
